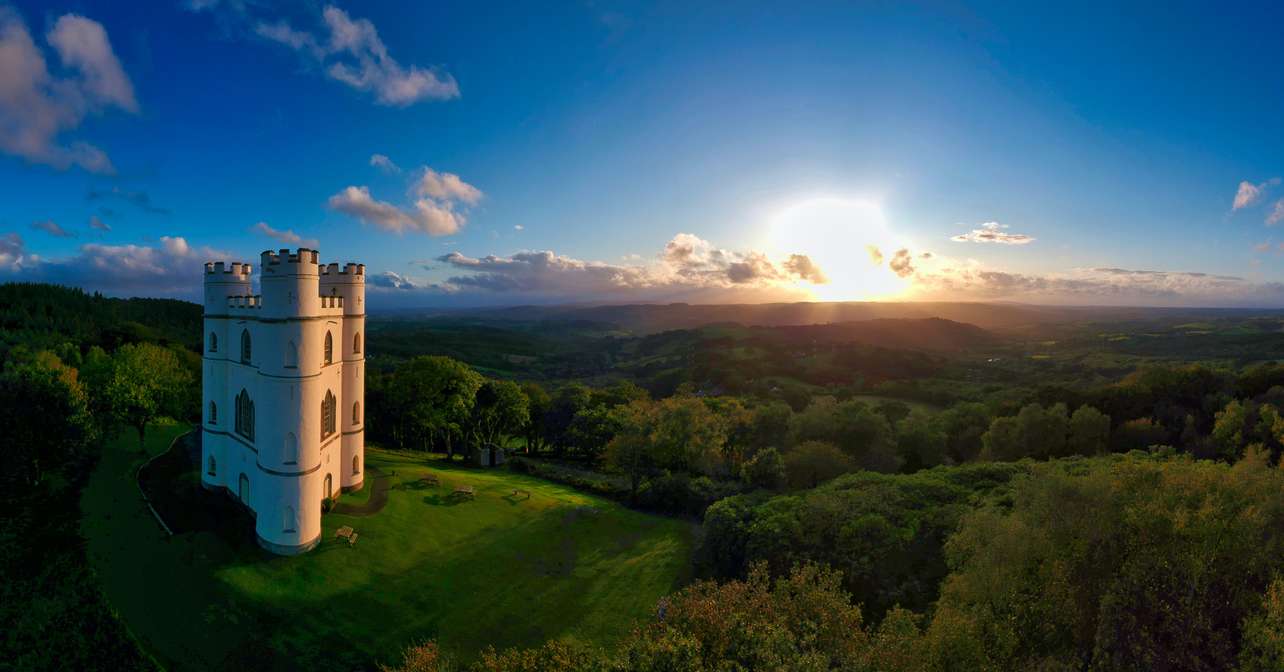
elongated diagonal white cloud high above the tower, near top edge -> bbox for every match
[242,5,460,107]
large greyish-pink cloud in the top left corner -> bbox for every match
[0,6,139,173]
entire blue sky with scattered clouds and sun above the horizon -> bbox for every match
[0,0,1284,306]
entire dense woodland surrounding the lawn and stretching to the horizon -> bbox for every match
[0,284,1284,671]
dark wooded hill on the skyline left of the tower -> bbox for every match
[0,283,202,356]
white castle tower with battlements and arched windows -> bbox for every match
[200,248,366,554]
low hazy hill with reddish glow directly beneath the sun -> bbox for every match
[754,317,998,351]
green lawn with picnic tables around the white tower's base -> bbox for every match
[82,427,691,669]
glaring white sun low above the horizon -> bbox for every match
[767,198,909,301]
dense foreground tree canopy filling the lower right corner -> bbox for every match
[385,450,1284,672]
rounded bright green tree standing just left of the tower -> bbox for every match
[103,343,191,450]
